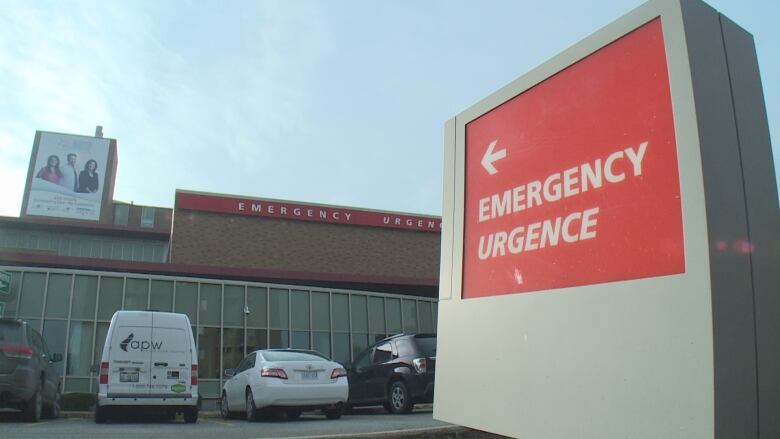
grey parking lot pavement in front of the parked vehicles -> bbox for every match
[0,408,494,439]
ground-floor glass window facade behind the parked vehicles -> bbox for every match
[0,266,437,397]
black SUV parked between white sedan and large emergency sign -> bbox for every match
[347,334,436,413]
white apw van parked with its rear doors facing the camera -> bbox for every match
[95,311,198,423]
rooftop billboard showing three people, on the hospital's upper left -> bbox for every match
[23,132,111,221]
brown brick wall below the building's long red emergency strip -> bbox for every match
[171,209,441,279]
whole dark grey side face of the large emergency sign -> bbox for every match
[682,1,780,438]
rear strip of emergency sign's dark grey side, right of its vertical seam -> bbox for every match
[720,15,780,438]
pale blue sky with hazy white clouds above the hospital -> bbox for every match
[0,0,780,216]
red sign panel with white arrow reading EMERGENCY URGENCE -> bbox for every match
[462,18,685,298]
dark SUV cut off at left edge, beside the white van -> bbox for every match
[0,319,62,422]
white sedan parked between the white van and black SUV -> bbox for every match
[220,349,349,421]
